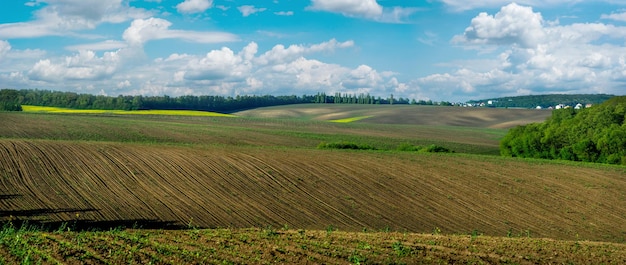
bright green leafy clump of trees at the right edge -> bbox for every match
[500,96,626,165]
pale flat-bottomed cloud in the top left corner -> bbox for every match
[0,0,151,38]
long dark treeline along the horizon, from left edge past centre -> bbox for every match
[0,89,420,112]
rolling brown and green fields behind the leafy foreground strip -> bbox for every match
[0,110,626,242]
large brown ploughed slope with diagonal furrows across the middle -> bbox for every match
[0,139,626,241]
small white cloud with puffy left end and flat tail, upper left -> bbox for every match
[123,18,237,45]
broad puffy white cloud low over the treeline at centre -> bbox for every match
[127,39,407,95]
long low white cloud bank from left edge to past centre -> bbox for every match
[0,36,415,96]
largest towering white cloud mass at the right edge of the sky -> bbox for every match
[416,3,626,99]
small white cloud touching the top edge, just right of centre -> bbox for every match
[309,0,383,19]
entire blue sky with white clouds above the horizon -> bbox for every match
[0,0,626,102]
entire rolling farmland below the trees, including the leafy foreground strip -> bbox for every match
[0,105,626,264]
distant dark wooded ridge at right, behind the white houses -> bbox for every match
[467,94,614,109]
